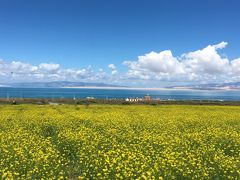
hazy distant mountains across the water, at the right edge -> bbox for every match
[172,82,240,90]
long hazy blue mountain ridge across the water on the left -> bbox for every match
[0,81,123,88]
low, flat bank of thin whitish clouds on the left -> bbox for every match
[0,60,107,82]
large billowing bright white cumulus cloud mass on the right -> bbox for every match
[123,42,240,82]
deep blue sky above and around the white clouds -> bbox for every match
[0,0,240,86]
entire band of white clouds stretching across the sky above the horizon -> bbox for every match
[0,42,240,86]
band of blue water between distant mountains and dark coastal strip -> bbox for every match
[0,87,240,101]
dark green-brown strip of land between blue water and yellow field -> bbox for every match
[0,98,240,106]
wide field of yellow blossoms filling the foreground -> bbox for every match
[0,105,240,179]
